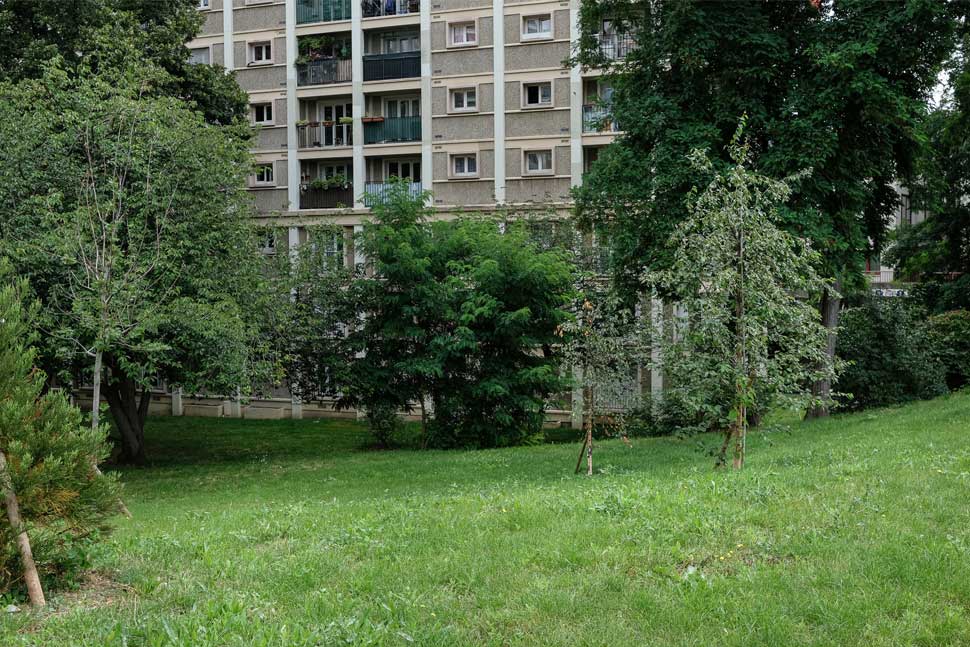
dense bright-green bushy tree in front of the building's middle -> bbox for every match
[344,182,571,447]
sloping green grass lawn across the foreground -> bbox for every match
[0,393,970,647]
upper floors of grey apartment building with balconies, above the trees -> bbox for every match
[189,0,632,238]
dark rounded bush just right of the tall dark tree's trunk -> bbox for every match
[836,298,947,409]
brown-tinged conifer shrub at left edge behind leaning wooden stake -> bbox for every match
[0,272,119,593]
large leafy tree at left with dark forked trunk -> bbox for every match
[0,64,261,462]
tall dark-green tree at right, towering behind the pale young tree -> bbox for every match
[576,0,959,415]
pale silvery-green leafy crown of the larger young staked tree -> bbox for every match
[646,127,831,456]
